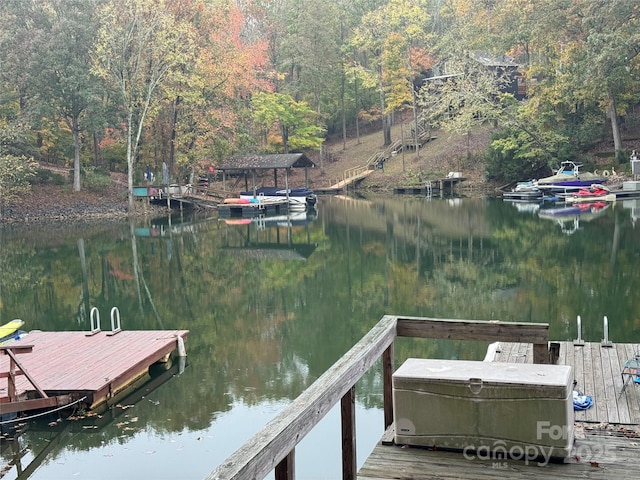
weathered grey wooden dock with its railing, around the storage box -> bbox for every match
[206,315,640,480]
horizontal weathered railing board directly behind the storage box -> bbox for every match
[396,317,549,343]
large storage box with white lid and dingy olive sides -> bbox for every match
[393,358,573,459]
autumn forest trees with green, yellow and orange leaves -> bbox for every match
[0,0,640,195]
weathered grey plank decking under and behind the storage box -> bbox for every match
[357,342,640,480]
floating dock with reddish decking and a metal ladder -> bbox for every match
[0,330,189,414]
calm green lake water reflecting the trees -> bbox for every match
[0,196,640,480]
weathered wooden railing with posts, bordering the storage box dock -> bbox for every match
[206,315,549,480]
